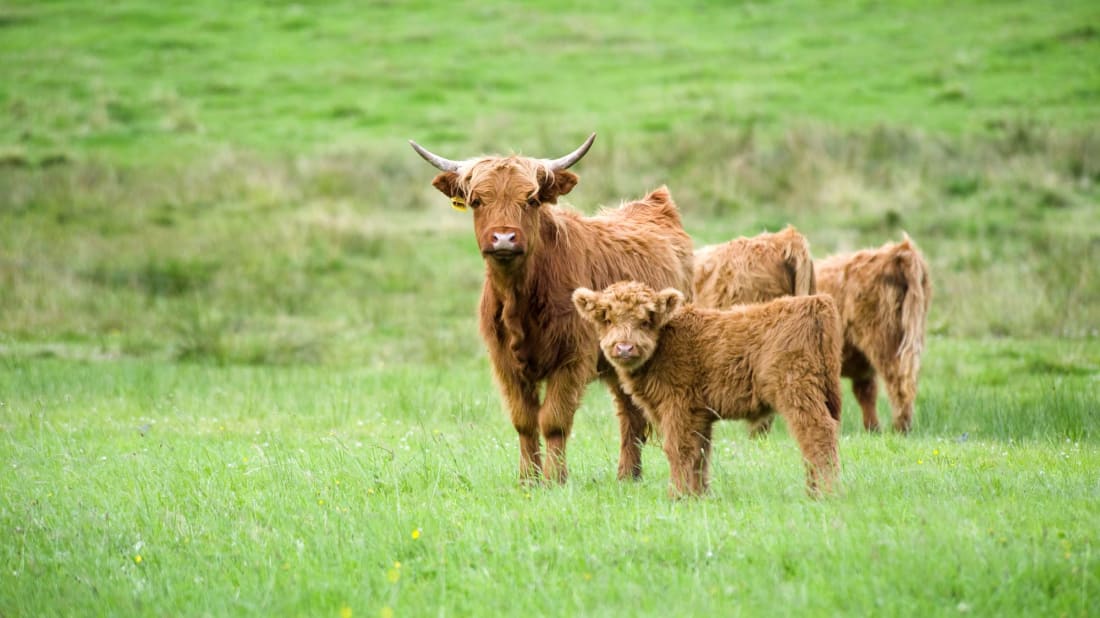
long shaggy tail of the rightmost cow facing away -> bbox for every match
[894,234,932,384]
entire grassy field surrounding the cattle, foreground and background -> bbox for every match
[0,0,1100,617]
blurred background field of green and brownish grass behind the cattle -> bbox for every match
[0,2,1100,365]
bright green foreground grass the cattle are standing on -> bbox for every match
[0,339,1100,616]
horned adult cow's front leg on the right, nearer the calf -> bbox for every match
[539,363,592,483]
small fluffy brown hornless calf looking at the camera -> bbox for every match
[573,282,842,495]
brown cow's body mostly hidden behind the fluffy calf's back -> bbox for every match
[693,225,816,309]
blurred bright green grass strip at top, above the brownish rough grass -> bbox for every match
[0,0,1100,162]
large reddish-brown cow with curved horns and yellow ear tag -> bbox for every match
[413,134,692,483]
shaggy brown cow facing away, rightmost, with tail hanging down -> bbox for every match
[815,234,932,432]
